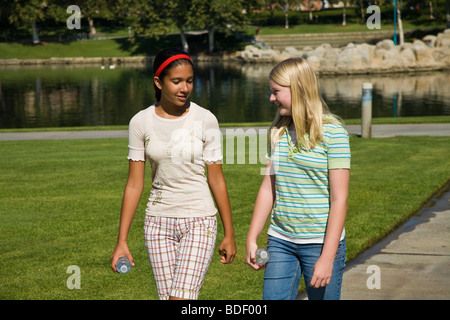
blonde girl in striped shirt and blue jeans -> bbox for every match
[246,58,350,299]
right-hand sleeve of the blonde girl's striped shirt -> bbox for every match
[324,125,351,169]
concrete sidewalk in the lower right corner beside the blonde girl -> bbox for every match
[298,191,450,300]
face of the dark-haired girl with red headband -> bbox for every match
[154,63,194,108]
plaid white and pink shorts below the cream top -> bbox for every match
[144,216,217,300]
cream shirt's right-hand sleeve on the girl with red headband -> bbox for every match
[203,113,223,163]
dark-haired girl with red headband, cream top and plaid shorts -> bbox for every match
[111,49,236,300]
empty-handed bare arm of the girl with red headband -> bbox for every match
[207,163,236,264]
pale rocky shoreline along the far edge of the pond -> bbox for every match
[0,29,450,74]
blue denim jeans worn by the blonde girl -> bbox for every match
[263,236,347,300]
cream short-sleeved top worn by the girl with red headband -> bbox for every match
[128,102,222,218]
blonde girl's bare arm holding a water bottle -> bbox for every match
[246,161,275,270]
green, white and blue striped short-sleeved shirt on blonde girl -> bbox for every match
[269,123,351,239]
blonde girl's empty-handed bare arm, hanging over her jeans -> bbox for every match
[310,169,350,288]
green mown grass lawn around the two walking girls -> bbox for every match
[0,136,450,300]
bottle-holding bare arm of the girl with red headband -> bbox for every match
[111,160,145,271]
